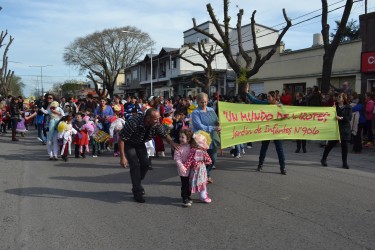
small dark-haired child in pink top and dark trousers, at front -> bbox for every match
[174,129,193,207]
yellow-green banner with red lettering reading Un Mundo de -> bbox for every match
[219,102,340,148]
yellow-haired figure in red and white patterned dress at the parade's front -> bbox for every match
[184,130,212,203]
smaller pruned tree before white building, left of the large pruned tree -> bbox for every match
[179,42,223,95]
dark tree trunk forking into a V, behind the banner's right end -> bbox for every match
[321,0,353,93]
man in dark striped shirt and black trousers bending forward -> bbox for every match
[119,108,179,203]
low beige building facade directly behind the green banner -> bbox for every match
[244,40,362,94]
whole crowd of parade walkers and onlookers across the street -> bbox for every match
[0,82,375,206]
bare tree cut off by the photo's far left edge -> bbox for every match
[0,31,14,96]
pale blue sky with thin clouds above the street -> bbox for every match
[0,0,375,96]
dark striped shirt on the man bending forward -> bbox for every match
[120,115,168,145]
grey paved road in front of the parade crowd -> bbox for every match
[0,131,375,250]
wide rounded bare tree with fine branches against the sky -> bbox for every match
[64,26,154,98]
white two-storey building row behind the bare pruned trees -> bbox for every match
[121,22,278,98]
